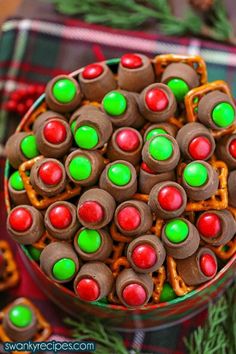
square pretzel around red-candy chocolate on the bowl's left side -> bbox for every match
[19,156,81,209]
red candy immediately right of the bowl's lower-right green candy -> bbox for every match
[197,213,221,238]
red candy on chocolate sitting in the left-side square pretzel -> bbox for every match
[39,161,62,186]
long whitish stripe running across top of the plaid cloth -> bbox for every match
[2,19,236,66]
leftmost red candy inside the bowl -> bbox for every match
[9,207,33,232]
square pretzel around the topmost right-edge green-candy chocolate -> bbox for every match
[185,80,236,138]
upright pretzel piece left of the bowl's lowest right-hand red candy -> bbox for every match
[167,256,194,296]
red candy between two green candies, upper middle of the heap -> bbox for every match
[116,129,140,152]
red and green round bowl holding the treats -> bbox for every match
[4,59,236,331]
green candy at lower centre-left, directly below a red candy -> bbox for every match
[77,229,102,253]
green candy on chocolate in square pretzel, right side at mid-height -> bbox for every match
[183,162,208,187]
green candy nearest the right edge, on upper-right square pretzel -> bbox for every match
[211,102,235,128]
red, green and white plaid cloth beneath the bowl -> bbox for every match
[0,14,236,354]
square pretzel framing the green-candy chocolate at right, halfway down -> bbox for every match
[177,156,228,212]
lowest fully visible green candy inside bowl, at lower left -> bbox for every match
[52,258,76,281]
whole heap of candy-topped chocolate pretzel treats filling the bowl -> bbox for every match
[6,53,236,308]
